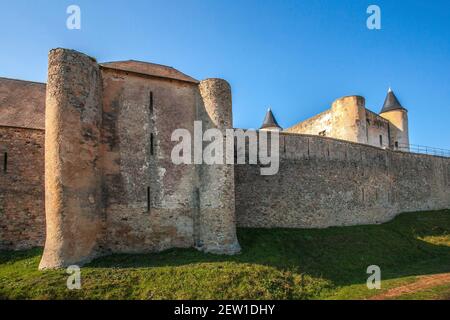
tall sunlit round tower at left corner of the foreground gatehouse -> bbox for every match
[39,49,103,269]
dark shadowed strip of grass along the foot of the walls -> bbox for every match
[0,210,450,285]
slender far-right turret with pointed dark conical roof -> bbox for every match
[380,88,409,151]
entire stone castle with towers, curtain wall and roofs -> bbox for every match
[0,49,450,269]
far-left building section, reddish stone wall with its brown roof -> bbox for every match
[0,78,45,249]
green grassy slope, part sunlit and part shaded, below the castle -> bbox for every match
[0,210,450,299]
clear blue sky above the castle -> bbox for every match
[0,0,450,149]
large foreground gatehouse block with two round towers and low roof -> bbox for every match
[40,49,240,269]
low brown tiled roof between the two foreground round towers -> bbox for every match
[100,60,199,84]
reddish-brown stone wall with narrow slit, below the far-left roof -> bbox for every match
[0,126,45,249]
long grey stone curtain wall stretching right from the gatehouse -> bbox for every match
[235,133,450,228]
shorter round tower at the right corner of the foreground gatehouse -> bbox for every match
[196,79,241,254]
